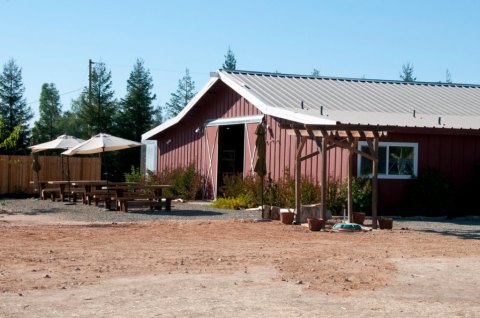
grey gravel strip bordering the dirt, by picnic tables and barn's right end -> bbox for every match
[0,199,480,239]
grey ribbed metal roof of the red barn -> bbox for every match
[218,70,480,129]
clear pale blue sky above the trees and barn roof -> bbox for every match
[0,0,480,123]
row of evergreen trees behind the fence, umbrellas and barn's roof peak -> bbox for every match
[0,47,236,178]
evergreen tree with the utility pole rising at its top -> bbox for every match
[78,63,117,138]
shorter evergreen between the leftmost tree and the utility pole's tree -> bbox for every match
[32,83,62,143]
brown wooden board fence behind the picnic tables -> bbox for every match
[0,155,101,194]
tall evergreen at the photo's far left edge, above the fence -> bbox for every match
[0,59,33,154]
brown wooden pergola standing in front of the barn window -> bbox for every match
[282,123,388,229]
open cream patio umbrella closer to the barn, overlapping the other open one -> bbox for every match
[62,133,142,181]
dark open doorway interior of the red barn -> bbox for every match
[217,125,245,192]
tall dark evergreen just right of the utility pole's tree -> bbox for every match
[117,59,156,141]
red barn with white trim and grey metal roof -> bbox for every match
[142,70,480,216]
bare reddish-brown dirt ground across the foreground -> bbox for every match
[0,212,480,317]
